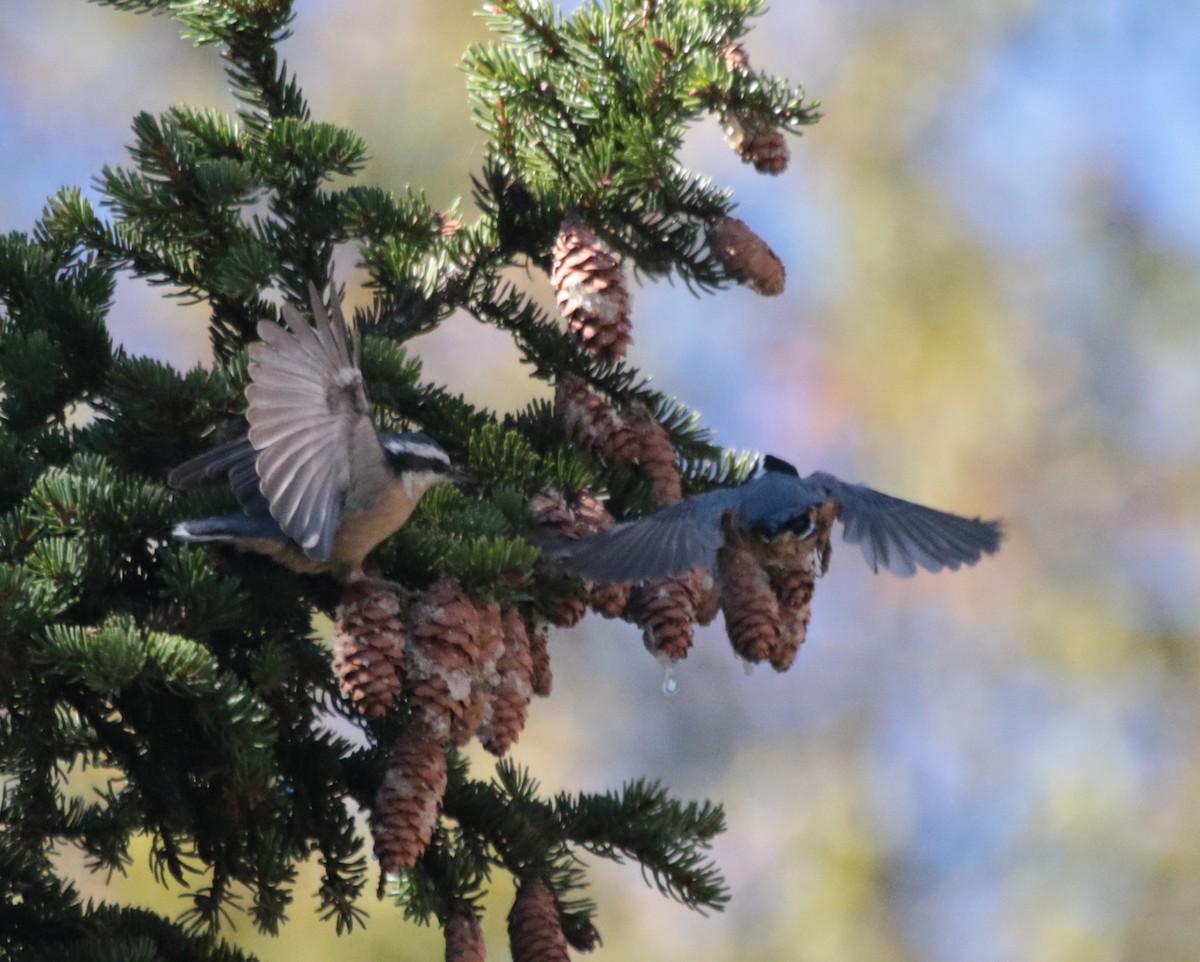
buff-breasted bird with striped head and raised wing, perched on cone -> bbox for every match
[167,277,463,584]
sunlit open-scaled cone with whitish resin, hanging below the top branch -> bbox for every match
[550,215,632,361]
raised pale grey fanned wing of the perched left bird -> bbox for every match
[246,285,384,561]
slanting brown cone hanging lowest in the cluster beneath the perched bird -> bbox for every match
[371,724,446,876]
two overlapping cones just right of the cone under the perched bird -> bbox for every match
[404,578,504,745]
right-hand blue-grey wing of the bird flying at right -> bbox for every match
[804,473,1002,577]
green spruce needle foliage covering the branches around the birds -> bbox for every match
[0,0,816,962]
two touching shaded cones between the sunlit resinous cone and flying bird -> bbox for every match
[554,373,682,504]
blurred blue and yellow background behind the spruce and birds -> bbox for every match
[0,0,1200,962]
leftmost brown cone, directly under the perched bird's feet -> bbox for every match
[334,584,404,717]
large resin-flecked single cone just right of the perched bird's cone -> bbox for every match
[404,577,486,739]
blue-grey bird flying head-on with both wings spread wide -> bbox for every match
[542,455,1003,584]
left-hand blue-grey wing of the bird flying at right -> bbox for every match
[542,488,737,584]
